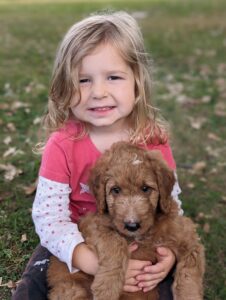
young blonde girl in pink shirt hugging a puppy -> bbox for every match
[13,12,180,300]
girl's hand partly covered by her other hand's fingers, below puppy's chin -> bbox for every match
[123,243,151,292]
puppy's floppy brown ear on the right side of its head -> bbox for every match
[149,151,175,214]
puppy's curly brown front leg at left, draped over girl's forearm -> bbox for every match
[79,215,129,300]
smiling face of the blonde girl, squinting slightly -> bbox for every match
[71,44,135,130]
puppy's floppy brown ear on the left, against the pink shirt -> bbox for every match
[88,153,112,214]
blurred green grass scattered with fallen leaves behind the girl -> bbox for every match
[0,0,226,300]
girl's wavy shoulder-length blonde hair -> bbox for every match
[40,11,167,148]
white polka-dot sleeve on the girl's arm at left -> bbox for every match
[32,176,84,272]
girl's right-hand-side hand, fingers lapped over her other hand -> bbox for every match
[135,247,176,292]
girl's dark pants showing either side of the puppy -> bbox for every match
[12,245,173,300]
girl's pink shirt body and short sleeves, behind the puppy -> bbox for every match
[39,122,175,222]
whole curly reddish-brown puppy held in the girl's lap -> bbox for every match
[48,142,204,300]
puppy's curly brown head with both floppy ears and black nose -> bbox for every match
[89,142,175,237]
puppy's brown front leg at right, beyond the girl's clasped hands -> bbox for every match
[173,244,205,300]
